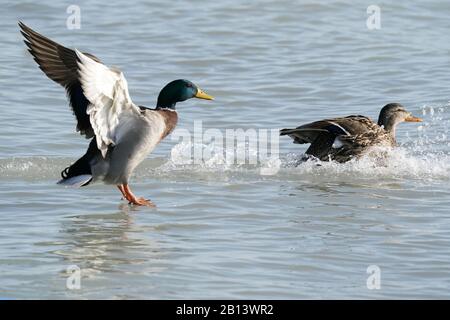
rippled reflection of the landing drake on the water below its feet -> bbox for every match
[54,208,163,278]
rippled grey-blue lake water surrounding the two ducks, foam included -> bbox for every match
[0,0,450,299]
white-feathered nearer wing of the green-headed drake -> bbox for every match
[75,50,139,158]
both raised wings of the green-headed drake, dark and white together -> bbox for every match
[19,22,139,157]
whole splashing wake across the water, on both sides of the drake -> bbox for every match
[0,103,450,181]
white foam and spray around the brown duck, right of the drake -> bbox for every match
[159,104,450,180]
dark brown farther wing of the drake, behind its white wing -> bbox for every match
[19,22,100,138]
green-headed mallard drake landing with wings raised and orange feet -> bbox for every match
[19,22,213,206]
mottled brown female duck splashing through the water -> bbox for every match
[280,103,422,162]
